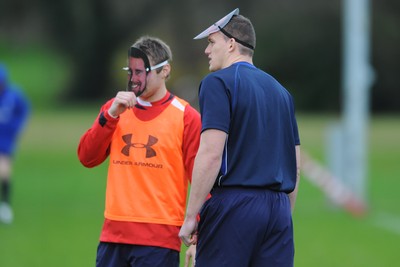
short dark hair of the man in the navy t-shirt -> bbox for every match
[223,15,256,56]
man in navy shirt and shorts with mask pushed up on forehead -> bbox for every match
[179,9,300,267]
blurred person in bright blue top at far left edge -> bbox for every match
[0,63,30,224]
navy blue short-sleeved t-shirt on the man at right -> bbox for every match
[199,62,300,192]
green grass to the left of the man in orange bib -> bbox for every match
[0,113,105,267]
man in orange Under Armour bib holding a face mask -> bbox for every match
[78,36,201,267]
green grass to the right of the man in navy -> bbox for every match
[294,116,400,267]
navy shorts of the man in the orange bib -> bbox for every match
[96,242,179,267]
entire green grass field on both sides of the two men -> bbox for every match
[0,109,400,267]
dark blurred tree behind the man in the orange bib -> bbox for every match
[39,0,166,101]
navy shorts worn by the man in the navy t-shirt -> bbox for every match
[196,188,294,267]
